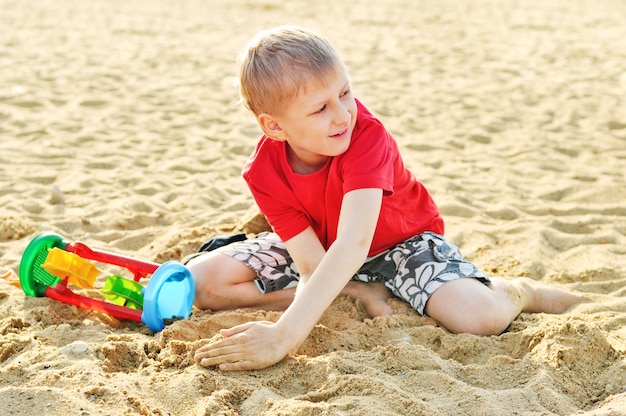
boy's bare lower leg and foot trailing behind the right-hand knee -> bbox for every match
[511,277,590,313]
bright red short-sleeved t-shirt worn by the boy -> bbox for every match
[243,101,444,256]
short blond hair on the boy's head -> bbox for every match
[238,26,341,115]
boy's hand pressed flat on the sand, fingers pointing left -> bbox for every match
[194,321,293,371]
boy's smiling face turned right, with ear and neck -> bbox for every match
[260,65,357,173]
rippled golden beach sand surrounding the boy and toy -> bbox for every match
[0,0,626,415]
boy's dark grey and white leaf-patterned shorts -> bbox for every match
[216,232,491,315]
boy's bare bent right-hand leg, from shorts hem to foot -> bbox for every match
[425,278,585,335]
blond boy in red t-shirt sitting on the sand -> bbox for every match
[188,26,581,371]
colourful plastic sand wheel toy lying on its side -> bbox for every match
[19,232,195,332]
